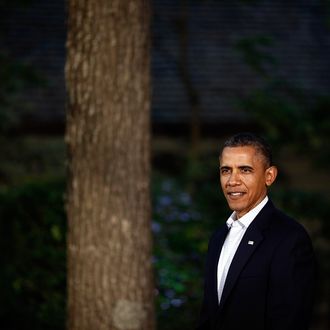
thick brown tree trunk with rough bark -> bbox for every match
[66,0,155,330]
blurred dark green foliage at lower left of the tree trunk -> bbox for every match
[0,179,66,330]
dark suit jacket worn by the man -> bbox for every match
[198,201,315,330]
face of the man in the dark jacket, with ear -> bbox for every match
[220,146,277,218]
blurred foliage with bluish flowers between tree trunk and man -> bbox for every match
[152,173,226,330]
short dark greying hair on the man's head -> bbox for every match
[222,132,273,167]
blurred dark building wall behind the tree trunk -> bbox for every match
[0,0,330,134]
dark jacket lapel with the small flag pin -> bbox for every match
[219,201,274,309]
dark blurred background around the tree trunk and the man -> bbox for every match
[0,0,330,330]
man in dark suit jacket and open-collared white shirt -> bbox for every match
[198,133,315,330]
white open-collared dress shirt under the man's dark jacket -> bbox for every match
[217,196,268,303]
